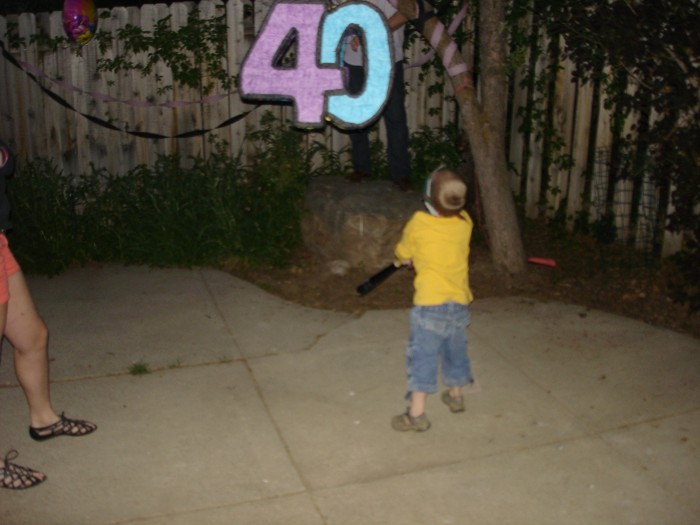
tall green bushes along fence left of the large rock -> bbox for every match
[9,113,310,275]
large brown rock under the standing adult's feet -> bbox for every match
[302,177,422,271]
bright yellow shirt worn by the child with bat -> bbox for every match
[394,211,474,306]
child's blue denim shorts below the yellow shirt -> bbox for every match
[406,303,473,392]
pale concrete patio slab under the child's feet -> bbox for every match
[0,266,700,525]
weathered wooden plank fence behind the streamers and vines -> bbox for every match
[0,0,680,253]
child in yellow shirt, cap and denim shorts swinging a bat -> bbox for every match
[391,167,474,432]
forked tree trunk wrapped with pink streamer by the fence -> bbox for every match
[397,0,525,274]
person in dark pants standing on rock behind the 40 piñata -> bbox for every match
[343,0,411,191]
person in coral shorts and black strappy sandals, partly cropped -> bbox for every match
[0,141,97,489]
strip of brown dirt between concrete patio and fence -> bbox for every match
[223,226,700,338]
